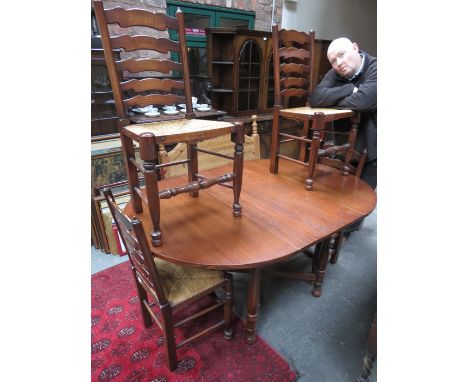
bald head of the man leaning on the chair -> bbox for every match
[327,37,362,78]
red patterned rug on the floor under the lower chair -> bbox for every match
[91,261,296,382]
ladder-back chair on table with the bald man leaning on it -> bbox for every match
[270,24,364,190]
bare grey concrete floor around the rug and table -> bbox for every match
[91,211,377,382]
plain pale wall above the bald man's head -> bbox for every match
[280,0,377,56]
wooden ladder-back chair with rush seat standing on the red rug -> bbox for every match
[104,189,233,370]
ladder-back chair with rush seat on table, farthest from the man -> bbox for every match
[94,0,244,246]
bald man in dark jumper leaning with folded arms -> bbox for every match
[309,37,377,188]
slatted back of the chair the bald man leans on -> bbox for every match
[272,24,315,108]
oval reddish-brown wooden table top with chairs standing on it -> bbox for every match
[125,159,377,269]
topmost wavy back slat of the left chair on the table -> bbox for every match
[106,7,178,31]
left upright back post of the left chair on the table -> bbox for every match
[94,0,126,118]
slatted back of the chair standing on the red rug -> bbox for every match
[103,188,167,305]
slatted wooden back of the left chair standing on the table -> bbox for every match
[94,0,194,119]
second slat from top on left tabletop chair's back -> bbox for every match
[110,35,180,53]
